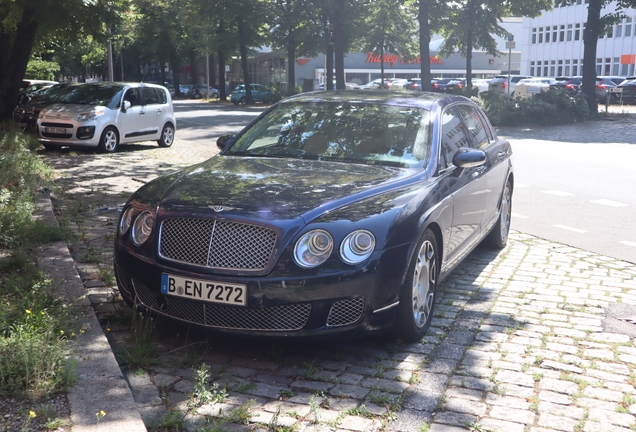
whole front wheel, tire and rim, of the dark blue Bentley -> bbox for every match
[393,229,439,342]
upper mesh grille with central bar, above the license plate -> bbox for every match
[159,218,276,270]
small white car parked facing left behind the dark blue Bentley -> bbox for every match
[37,82,177,153]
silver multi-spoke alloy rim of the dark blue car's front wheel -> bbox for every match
[412,240,437,328]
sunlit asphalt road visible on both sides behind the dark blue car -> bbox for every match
[175,101,636,263]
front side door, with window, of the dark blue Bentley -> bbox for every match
[438,106,487,262]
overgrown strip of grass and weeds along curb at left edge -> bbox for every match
[0,127,79,400]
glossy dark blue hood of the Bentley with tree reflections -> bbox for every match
[159,156,423,223]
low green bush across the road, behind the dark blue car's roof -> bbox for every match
[473,89,590,126]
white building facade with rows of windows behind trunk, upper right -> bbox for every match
[521,0,636,77]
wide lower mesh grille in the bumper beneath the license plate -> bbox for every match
[132,280,311,331]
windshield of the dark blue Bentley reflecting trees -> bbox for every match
[224,102,431,168]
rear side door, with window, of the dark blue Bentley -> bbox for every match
[457,104,510,228]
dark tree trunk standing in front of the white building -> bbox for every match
[581,0,603,114]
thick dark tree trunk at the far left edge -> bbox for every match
[0,8,38,121]
